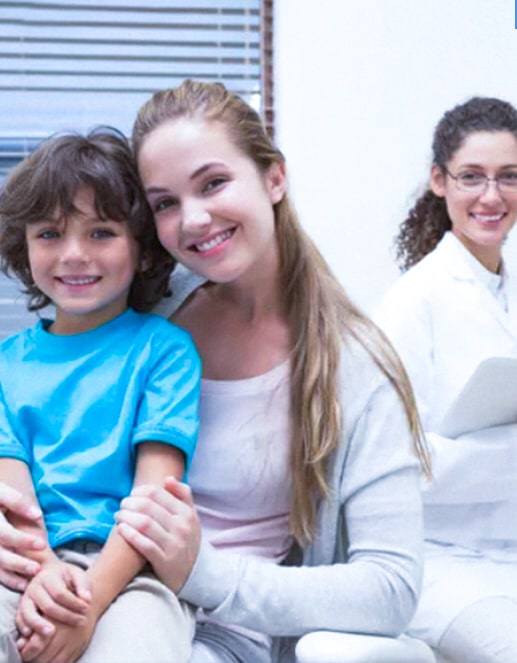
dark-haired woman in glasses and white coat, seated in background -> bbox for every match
[376,97,517,663]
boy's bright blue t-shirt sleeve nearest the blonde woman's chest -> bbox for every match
[133,322,201,469]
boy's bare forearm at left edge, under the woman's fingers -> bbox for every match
[0,458,55,564]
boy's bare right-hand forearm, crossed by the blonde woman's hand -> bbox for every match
[83,442,185,617]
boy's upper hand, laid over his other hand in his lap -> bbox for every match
[16,558,91,636]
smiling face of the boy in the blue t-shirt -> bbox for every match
[25,188,139,334]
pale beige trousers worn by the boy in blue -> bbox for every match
[0,543,195,663]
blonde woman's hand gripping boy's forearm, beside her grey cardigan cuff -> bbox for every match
[116,477,201,593]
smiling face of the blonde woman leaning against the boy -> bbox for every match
[138,119,285,283]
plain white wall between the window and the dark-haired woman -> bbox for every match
[275,0,517,311]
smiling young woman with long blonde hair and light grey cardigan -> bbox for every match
[0,81,425,663]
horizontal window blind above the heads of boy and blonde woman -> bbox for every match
[0,0,262,179]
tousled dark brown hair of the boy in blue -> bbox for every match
[0,126,175,311]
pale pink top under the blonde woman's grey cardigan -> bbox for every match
[189,361,292,562]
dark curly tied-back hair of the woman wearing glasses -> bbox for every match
[395,97,517,271]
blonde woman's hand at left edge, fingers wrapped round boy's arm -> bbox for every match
[0,483,46,591]
